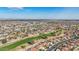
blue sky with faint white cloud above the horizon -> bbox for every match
[0,7,79,19]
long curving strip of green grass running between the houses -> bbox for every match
[0,31,62,51]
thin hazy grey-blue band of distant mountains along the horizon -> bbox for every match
[0,19,79,21]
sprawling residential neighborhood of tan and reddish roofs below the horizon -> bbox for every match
[0,20,79,51]
